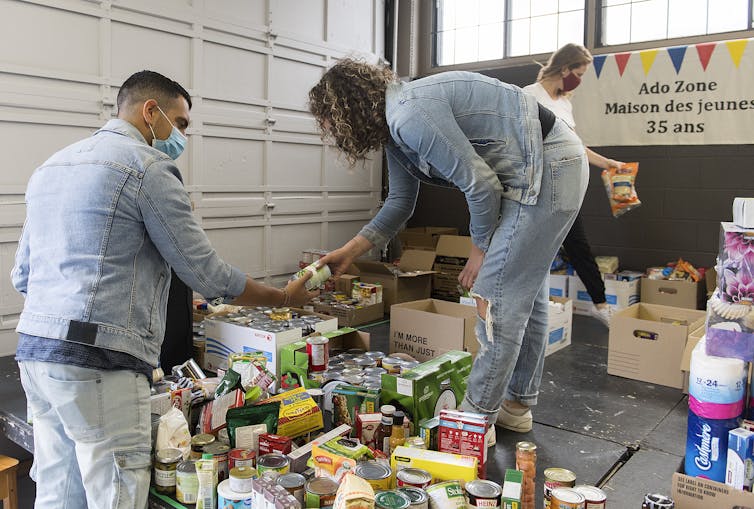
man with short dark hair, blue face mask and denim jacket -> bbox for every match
[11,71,315,509]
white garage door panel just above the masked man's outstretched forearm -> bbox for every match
[207,226,266,275]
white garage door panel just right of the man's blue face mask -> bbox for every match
[198,136,264,186]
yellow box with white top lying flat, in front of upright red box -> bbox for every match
[390,446,472,483]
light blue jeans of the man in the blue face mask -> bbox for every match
[19,361,151,509]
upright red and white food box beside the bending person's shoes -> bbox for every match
[437,410,487,479]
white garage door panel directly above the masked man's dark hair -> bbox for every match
[111,22,193,89]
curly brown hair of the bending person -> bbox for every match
[309,58,397,165]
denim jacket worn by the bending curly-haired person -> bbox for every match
[359,71,542,251]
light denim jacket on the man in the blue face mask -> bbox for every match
[11,119,246,366]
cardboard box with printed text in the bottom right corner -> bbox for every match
[670,472,754,509]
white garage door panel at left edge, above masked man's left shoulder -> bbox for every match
[0,122,94,186]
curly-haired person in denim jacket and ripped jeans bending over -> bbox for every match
[309,59,588,442]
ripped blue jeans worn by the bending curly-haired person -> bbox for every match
[461,121,589,423]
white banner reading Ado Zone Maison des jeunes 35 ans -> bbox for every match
[572,39,754,147]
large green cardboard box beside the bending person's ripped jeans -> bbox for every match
[380,350,472,434]
